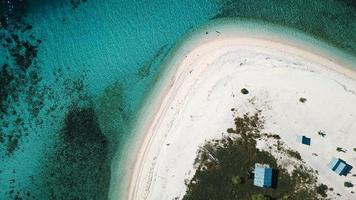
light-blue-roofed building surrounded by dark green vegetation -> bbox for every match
[253,163,273,188]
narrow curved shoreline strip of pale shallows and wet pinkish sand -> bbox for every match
[114,19,356,199]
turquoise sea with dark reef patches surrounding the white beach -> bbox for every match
[0,0,356,199]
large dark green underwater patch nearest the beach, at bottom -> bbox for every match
[43,106,110,200]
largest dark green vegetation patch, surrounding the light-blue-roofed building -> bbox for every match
[183,111,327,200]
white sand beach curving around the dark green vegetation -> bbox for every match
[123,23,356,200]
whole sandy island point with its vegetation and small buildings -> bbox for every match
[123,20,356,200]
